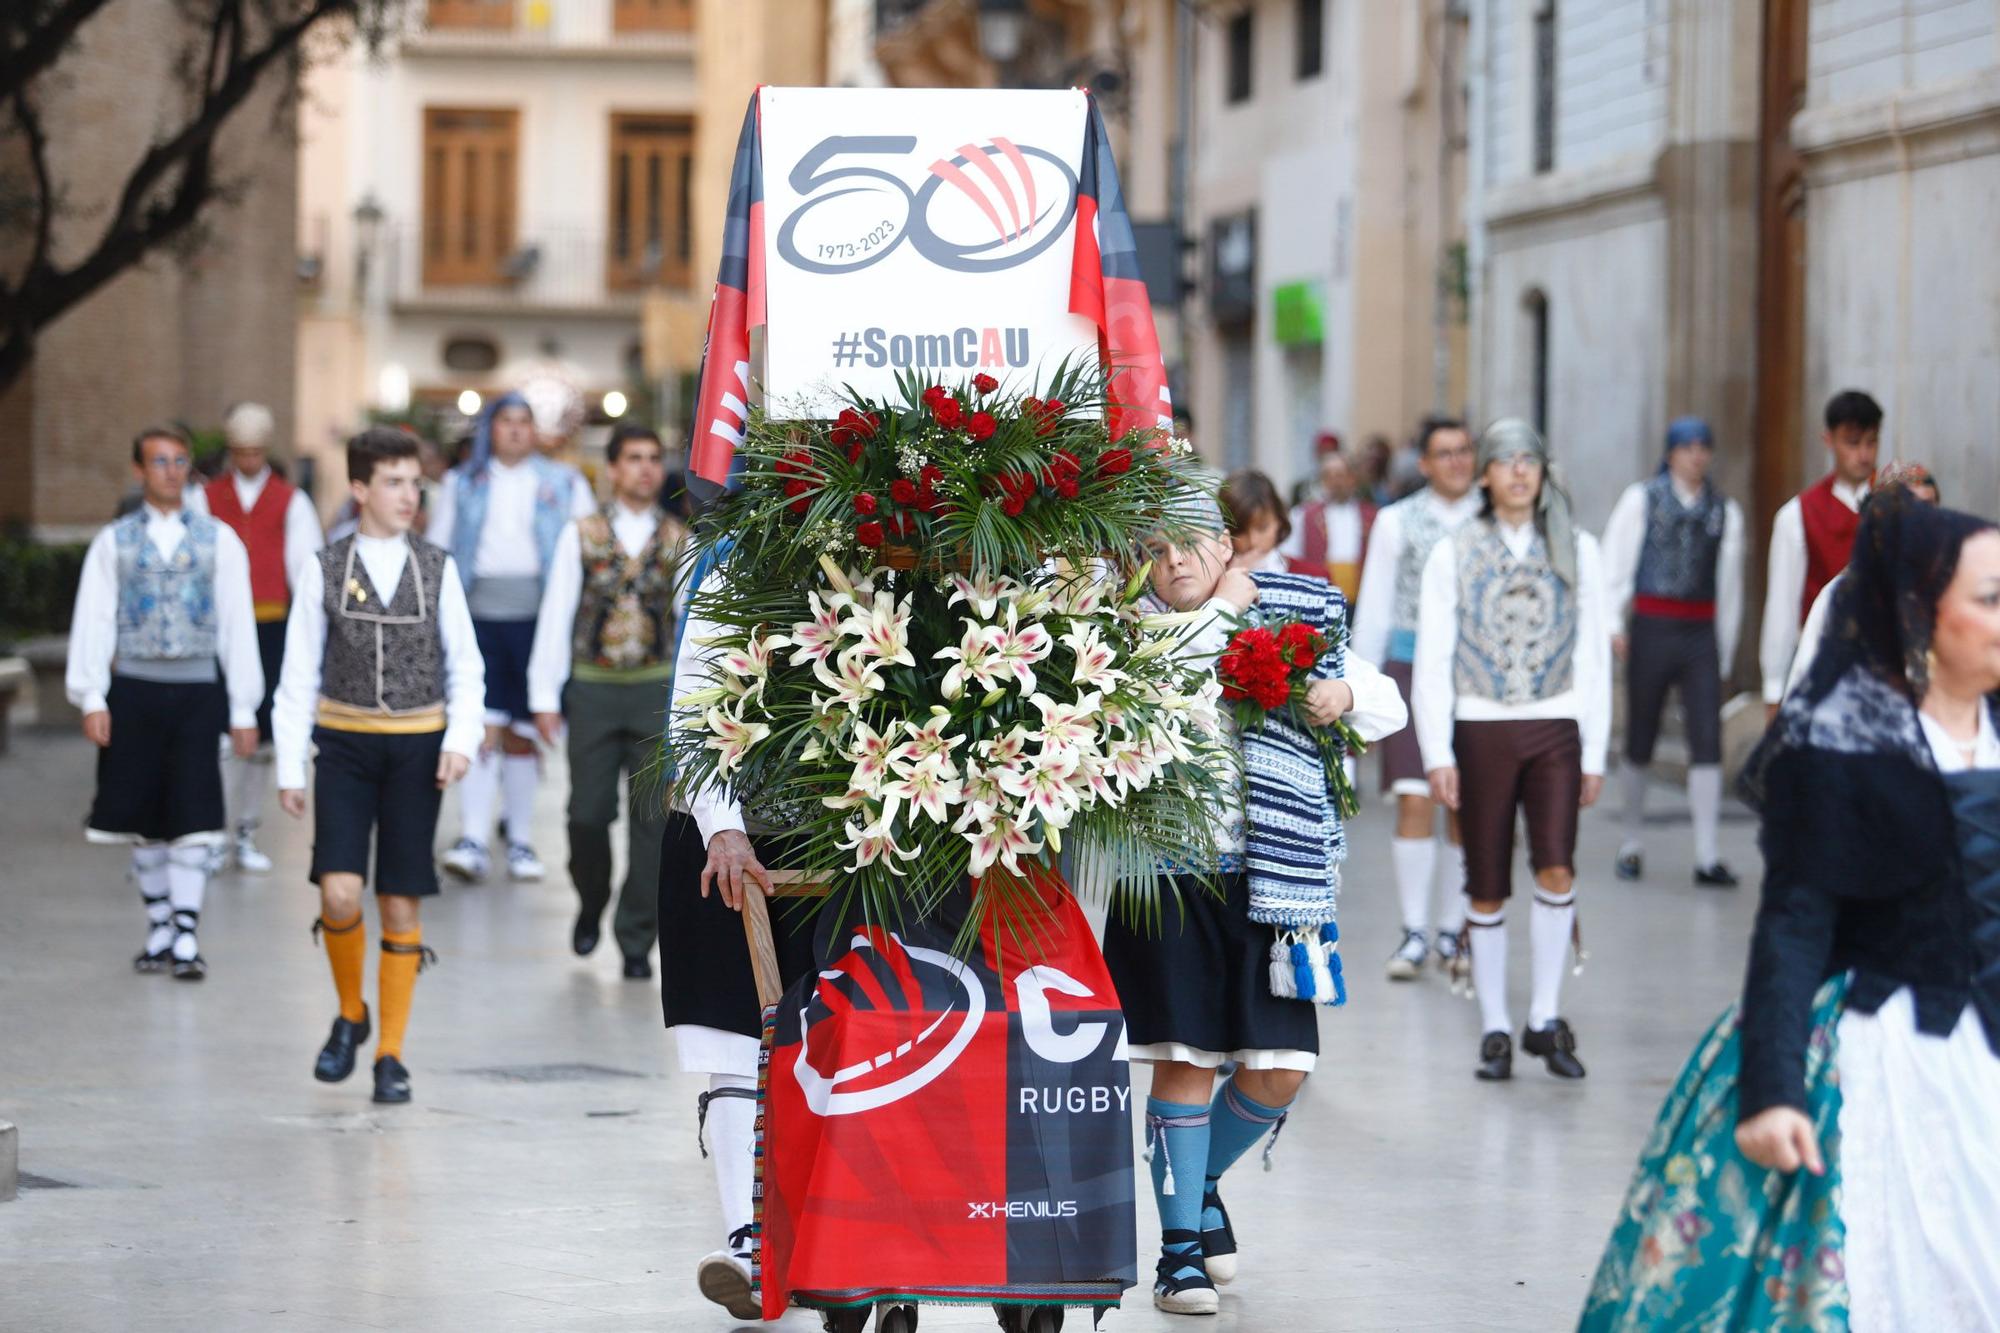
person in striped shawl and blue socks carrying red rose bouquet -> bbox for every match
[1104,504,1408,1315]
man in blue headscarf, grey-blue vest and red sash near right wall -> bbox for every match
[1604,416,1744,889]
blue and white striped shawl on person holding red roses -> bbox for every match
[1240,574,1348,931]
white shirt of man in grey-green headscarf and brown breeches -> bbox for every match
[1410,522,1612,775]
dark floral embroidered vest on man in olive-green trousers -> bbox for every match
[570,514,680,673]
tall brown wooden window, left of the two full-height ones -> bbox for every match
[424,106,520,286]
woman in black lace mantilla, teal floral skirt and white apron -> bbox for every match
[1582,488,2000,1331]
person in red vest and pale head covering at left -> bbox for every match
[188,402,326,875]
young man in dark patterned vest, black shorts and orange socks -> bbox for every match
[272,428,486,1103]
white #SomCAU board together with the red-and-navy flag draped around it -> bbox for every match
[690,88,1172,482]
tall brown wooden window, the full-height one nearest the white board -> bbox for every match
[604,114,694,288]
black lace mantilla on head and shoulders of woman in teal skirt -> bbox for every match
[1738,486,1994,811]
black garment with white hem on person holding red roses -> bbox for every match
[1104,875,1320,1069]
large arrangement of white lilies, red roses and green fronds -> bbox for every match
[670,368,1236,939]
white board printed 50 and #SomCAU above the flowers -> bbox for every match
[760,88,1098,416]
